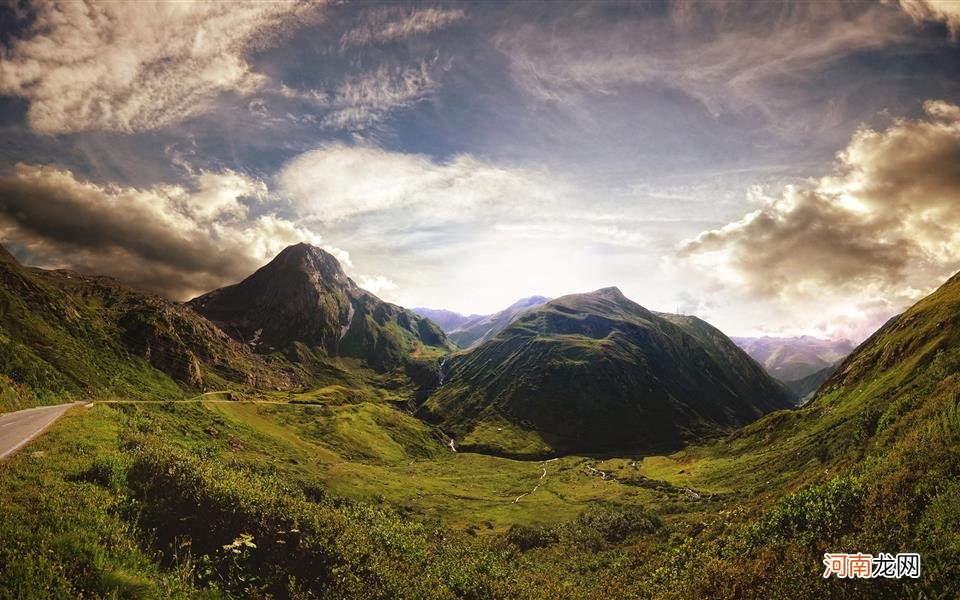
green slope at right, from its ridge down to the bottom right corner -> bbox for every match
[646,274,960,599]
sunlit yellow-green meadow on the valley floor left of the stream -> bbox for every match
[191,403,684,533]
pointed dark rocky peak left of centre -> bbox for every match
[188,244,452,371]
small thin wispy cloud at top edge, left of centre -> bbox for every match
[340,6,466,48]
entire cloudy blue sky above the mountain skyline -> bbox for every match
[0,0,960,341]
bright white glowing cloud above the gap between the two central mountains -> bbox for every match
[278,144,670,312]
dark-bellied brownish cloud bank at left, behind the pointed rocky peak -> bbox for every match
[0,164,349,299]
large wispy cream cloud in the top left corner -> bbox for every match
[0,0,317,134]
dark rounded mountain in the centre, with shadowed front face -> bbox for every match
[420,288,790,456]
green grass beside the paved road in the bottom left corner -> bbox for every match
[0,408,195,598]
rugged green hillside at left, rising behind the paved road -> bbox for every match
[0,244,452,411]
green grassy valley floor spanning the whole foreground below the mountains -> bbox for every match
[0,376,960,598]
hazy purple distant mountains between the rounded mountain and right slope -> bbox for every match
[731,335,853,381]
